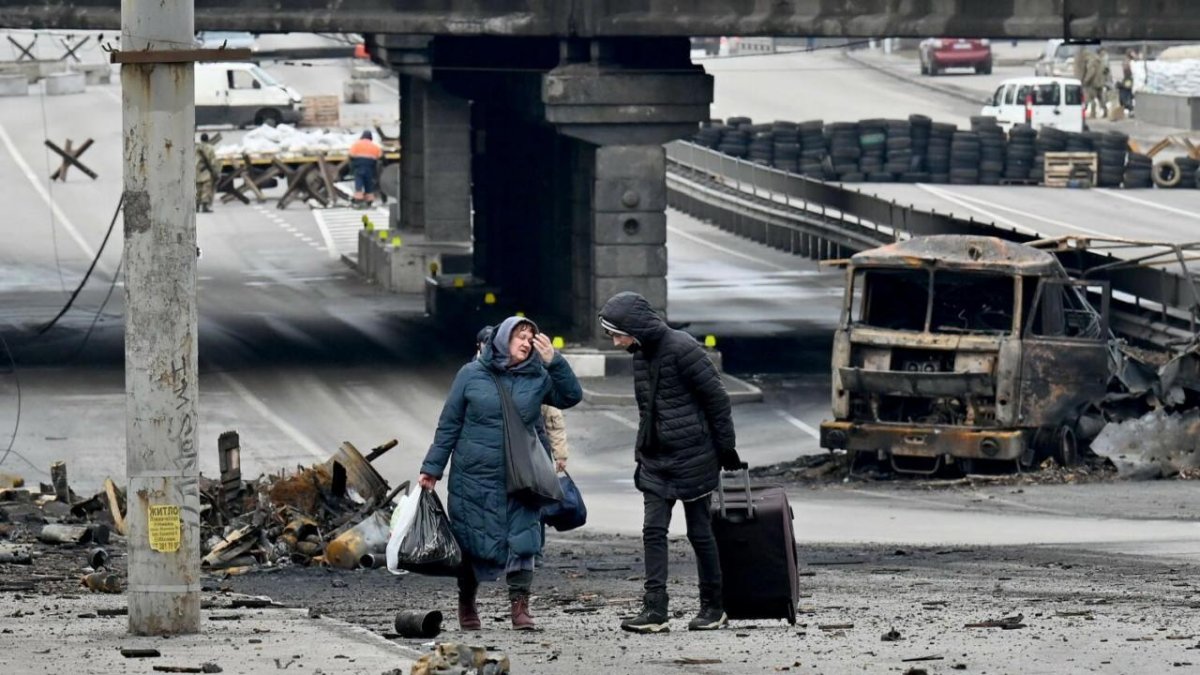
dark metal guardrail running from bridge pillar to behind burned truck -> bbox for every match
[666,141,1200,344]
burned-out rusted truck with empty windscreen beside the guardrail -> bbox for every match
[821,235,1115,472]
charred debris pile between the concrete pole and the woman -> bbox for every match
[200,431,408,575]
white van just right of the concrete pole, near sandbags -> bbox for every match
[196,62,301,126]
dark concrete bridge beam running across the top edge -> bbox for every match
[7,0,1200,40]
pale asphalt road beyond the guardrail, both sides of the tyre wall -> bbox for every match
[703,50,1200,249]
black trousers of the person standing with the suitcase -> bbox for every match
[642,492,721,603]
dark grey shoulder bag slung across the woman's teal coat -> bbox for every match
[488,371,563,508]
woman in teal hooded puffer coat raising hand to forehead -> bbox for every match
[419,316,583,631]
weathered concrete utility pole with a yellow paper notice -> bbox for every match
[121,0,200,635]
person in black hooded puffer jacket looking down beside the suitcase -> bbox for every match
[600,292,742,633]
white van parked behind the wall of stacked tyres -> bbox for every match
[979,77,1085,131]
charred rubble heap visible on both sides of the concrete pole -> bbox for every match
[0,431,408,583]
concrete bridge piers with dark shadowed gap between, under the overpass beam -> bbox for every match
[384,34,713,342]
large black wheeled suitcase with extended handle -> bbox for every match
[713,468,800,625]
